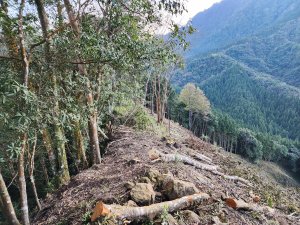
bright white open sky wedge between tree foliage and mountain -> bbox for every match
[175,0,222,25]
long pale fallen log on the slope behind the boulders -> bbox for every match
[149,150,252,186]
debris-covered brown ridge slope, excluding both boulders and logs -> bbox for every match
[34,119,300,224]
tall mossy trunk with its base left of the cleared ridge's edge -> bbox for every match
[35,0,70,185]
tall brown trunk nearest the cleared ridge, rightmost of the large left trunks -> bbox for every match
[64,0,101,164]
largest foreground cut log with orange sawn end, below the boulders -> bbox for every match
[91,193,210,222]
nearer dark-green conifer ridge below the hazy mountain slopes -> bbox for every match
[174,54,300,139]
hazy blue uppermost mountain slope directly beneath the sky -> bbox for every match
[188,0,300,56]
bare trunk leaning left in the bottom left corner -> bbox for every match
[0,169,20,225]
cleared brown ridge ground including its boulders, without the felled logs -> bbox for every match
[34,118,300,225]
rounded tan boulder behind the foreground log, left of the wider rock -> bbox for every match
[130,183,155,205]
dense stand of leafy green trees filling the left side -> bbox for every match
[0,0,191,224]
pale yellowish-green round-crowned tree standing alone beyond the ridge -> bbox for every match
[179,83,211,129]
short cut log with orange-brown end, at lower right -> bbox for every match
[225,198,275,215]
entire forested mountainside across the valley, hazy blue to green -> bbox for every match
[173,0,300,139]
